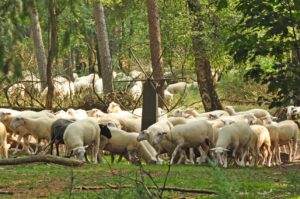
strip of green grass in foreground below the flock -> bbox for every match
[0,156,300,199]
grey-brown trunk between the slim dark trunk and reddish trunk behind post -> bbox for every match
[94,1,113,93]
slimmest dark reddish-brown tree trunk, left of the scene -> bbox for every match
[46,0,57,109]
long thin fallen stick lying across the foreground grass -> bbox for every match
[74,184,217,195]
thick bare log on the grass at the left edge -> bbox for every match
[0,155,84,167]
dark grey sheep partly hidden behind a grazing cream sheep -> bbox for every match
[50,119,75,156]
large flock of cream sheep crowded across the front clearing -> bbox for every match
[0,102,300,167]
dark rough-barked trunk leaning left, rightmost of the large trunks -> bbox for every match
[188,0,222,111]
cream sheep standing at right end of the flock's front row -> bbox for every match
[266,120,299,164]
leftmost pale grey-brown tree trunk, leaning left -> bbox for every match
[28,0,47,89]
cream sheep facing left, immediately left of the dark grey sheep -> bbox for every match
[10,115,55,154]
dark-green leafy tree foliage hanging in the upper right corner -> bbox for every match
[228,0,300,108]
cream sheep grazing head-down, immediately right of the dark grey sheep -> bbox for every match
[63,118,111,163]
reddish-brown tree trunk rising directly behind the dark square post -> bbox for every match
[146,0,164,107]
